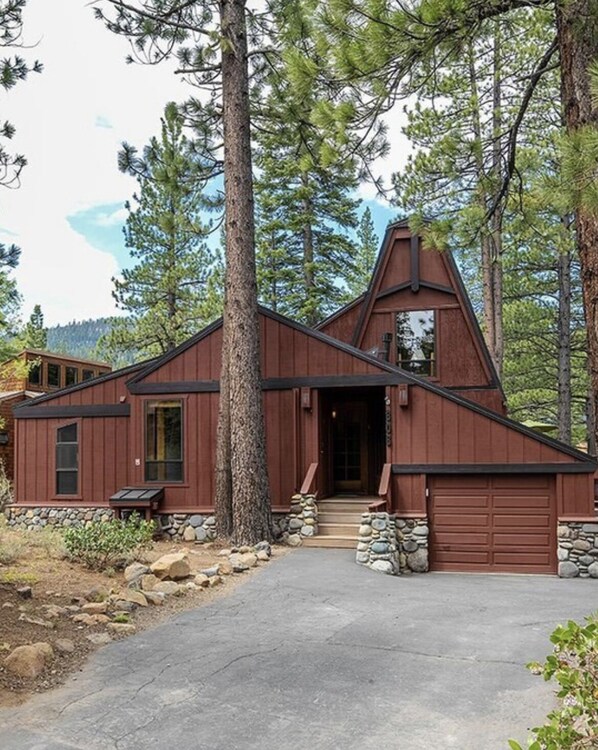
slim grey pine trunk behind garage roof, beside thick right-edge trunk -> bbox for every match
[557,247,571,443]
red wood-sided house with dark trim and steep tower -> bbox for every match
[12,223,598,575]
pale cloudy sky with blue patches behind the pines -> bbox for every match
[0,0,405,325]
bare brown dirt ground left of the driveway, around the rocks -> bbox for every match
[0,527,287,707]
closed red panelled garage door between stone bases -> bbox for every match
[430,474,557,573]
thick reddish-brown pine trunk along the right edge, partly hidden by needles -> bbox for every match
[556,0,598,452]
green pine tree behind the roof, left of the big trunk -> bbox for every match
[102,103,212,358]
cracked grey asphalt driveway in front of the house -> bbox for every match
[0,549,598,750]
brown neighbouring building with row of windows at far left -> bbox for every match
[0,349,112,479]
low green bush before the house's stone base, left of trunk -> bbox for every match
[64,514,156,570]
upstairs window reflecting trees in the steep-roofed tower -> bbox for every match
[396,310,436,375]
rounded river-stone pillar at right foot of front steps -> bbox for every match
[355,512,399,575]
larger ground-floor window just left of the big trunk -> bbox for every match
[145,401,183,482]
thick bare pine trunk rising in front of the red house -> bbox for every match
[218,0,271,544]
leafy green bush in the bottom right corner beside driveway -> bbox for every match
[509,615,598,750]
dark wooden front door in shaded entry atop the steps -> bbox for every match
[331,401,369,494]
